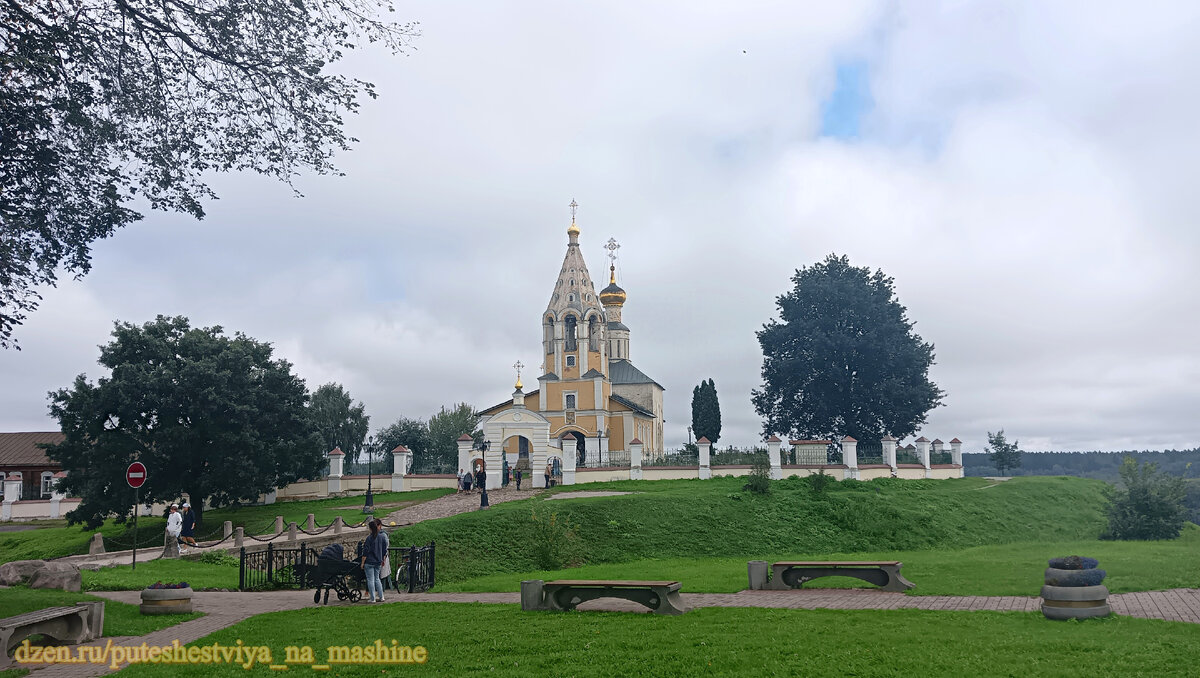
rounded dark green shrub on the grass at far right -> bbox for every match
[1102,457,1187,540]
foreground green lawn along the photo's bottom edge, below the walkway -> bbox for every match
[114,604,1200,678]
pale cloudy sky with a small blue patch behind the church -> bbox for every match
[0,0,1200,451]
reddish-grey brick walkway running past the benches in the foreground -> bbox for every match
[18,588,1200,678]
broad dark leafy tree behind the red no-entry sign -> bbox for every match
[48,316,324,527]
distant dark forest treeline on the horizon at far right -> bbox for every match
[962,448,1200,482]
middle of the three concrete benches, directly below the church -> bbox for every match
[521,580,688,614]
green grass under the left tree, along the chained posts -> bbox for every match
[0,488,454,563]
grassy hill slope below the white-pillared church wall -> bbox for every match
[392,478,1104,583]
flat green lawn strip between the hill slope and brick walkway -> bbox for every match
[437,526,1200,595]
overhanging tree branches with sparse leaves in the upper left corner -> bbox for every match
[0,0,416,347]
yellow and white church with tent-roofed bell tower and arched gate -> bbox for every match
[472,202,662,486]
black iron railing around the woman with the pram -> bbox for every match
[238,541,436,593]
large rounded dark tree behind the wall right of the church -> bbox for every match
[752,254,944,440]
